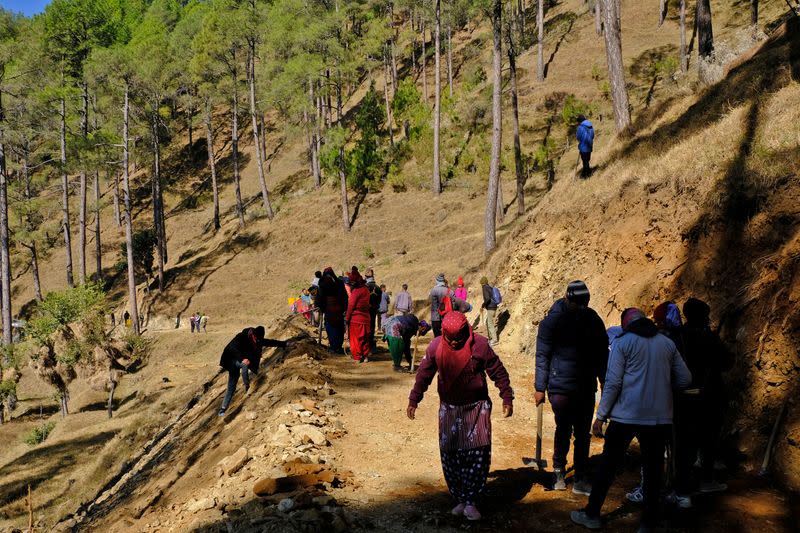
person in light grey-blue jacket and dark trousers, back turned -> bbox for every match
[570,308,692,532]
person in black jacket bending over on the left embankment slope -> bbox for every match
[219,326,288,416]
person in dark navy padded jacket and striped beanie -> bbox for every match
[534,280,608,495]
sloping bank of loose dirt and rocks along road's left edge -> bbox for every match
[49,317,355,532]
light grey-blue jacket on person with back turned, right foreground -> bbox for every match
[597,318,692,426]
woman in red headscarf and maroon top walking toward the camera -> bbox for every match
[406,311,514,520]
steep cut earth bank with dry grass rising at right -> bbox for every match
[491,16,800,488]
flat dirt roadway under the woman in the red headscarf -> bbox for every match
[326,338,800,532]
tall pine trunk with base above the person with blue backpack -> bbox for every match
[484,0,503,253]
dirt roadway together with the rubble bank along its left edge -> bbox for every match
[48,318,800,532]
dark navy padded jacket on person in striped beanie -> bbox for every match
[536,298,608,394]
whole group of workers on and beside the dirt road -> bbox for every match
[212,267,733,532]
